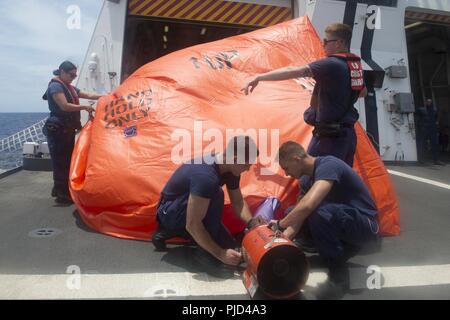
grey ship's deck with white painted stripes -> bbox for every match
[0,165,450,299]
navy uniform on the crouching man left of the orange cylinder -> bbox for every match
[157,158,240,249]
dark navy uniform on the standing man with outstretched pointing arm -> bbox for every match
[304,57,359,166]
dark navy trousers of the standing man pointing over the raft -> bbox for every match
[308,128,356,167]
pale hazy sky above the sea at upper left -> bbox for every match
[0,0,103,112]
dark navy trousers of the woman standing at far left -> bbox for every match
[44,128,75,196]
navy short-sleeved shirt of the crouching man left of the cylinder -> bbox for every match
[162,159,240,199]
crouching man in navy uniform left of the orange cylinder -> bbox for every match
[152,136,260,265]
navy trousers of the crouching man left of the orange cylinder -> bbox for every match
[157,189,236,249]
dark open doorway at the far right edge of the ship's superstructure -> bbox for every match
[405,9,450,161]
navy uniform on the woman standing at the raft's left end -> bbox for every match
[43,80,81,197]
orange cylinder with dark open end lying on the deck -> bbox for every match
[242,225,309,299]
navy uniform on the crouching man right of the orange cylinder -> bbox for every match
[300,156,379,260]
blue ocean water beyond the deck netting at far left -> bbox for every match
[0,112,48,172]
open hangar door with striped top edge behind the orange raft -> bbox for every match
[122,0,293,81]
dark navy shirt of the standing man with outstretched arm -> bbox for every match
[309,57,359,124]
